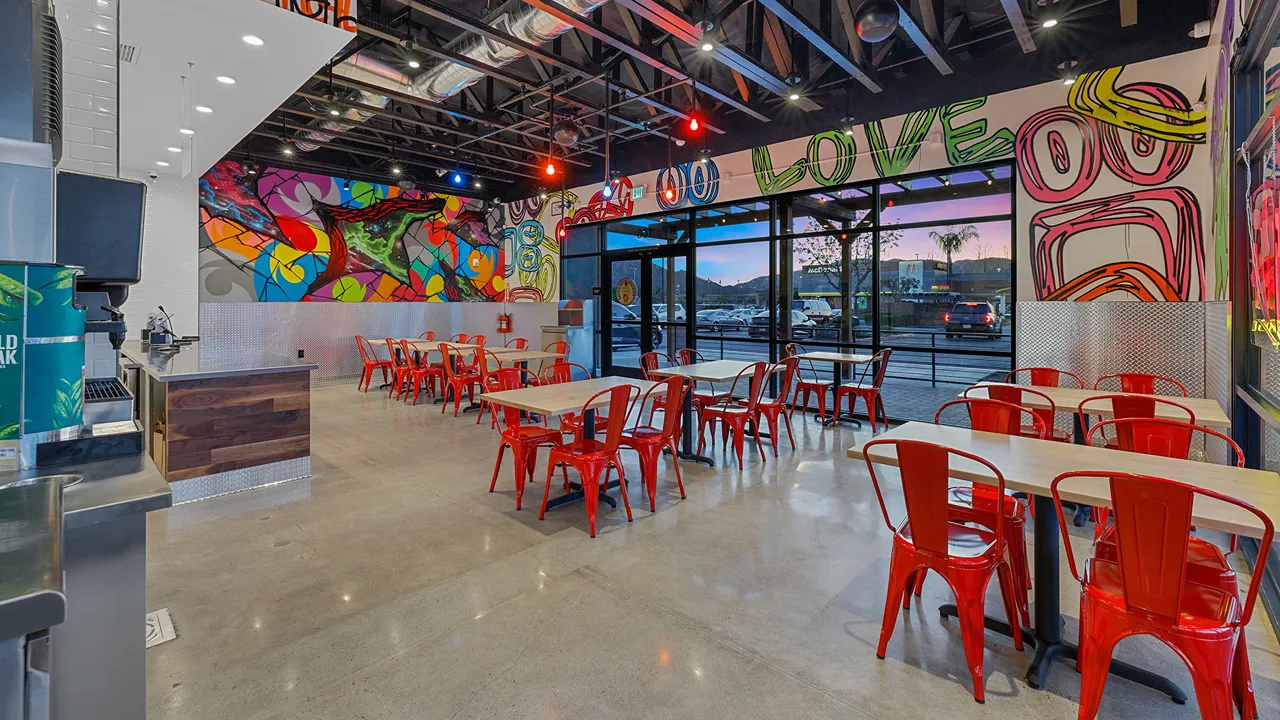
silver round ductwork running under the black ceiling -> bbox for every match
[296,0,619,151]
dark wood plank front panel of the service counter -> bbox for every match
[164,372,311,480]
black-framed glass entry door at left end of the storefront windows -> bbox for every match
[602,247,694,377]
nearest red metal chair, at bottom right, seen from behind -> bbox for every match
[1050,470,1275,720]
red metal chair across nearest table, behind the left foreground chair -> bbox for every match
[931,397,1048,625]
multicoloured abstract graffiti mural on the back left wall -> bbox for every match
[200,160,506,302]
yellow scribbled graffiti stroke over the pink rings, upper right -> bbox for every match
[1066,68,1208,143]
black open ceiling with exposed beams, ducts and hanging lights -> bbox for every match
[230,0,1213,200]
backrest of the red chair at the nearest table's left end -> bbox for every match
[863,438,1005,557]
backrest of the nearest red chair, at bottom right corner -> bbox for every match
[1054,470,1275,626]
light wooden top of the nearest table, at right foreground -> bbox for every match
[849,423,1280,538]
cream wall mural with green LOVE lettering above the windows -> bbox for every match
[504,51,1208,301]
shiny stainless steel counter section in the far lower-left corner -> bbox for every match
[0,482,67,641]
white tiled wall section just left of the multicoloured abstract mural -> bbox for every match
[124,170,200,338]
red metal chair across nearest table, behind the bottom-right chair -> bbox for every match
[1089,418,1257,717]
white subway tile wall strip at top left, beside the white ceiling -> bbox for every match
[56,0,120,176]
